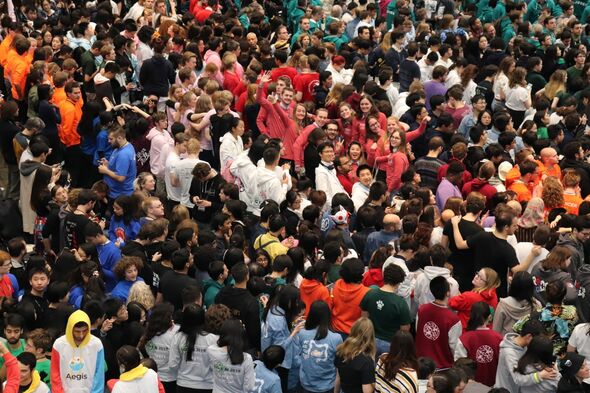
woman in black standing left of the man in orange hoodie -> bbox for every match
[37,84,63,165]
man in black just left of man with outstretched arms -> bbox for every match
[440,192,486,292]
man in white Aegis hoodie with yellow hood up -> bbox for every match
[51,310,105,393]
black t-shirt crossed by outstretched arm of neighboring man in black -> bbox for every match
[443,220,483,292]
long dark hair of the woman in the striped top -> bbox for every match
[381,330,418,381]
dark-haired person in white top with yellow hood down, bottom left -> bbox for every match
[107,345,160,393]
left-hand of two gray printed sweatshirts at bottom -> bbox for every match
[168,332,219,390]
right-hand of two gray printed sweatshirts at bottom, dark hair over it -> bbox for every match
[207,344,256,393]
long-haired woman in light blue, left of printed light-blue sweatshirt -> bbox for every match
[260,285,305,391]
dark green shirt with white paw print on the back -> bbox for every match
[361,288,412,342]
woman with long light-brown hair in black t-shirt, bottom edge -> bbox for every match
[334,318,375,393]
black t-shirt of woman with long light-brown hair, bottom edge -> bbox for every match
[334,355,375,393]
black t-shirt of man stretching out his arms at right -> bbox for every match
[467,232,518,298]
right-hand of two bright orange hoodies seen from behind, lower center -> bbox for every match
[332,279,369,334]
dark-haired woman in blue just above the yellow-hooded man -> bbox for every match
[68,261,105,310]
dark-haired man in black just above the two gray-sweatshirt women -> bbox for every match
[156,248,199,310]
